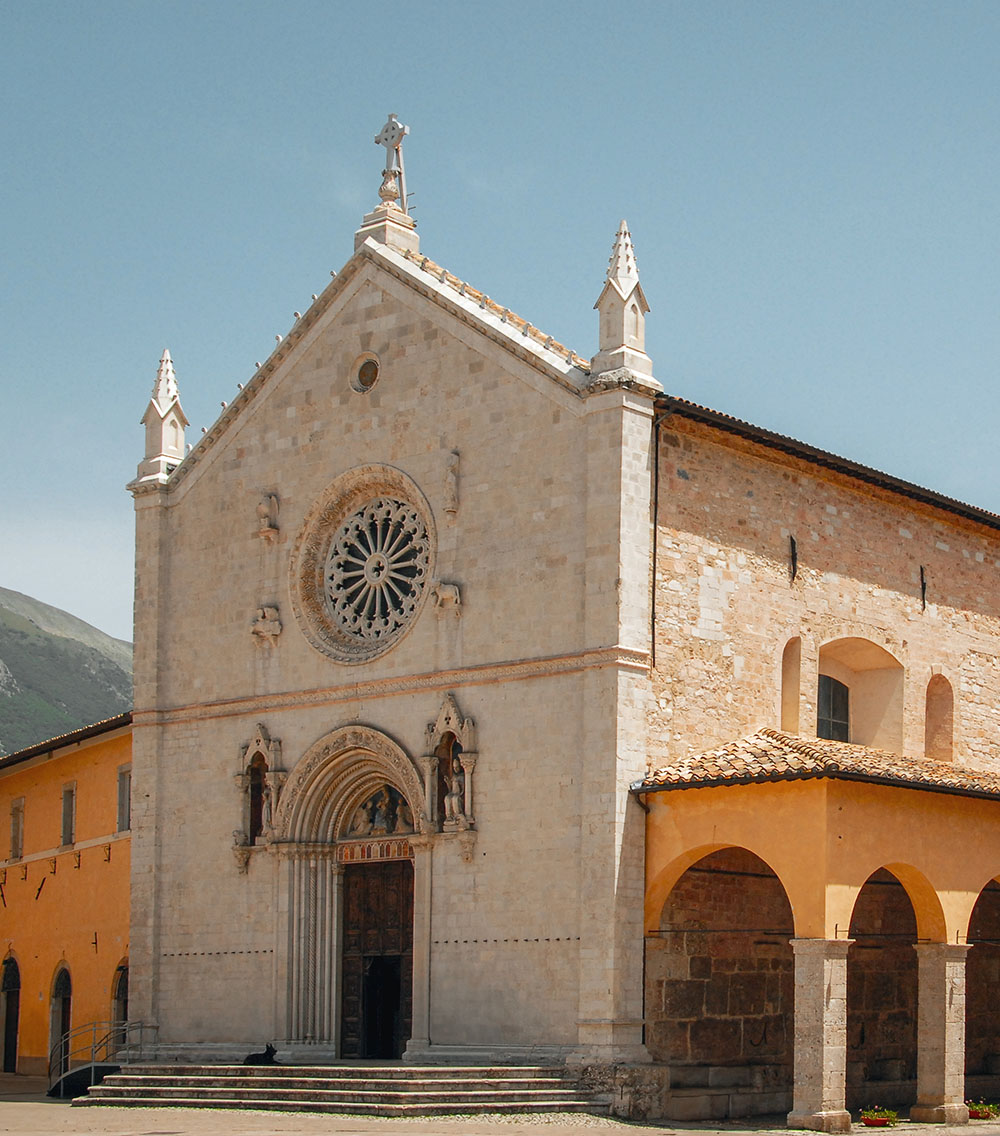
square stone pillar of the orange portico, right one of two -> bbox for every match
[910,943,968,1125]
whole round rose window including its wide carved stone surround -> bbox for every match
[290,466,436,662]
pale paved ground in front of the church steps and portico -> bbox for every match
[0,1074,1000,1136]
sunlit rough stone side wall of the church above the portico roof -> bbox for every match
[650,417,1000,767]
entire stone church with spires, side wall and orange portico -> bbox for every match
[130,124,1000,1130]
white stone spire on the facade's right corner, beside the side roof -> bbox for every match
[590,220,659,386]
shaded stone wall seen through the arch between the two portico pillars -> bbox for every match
[848,869,917,1106]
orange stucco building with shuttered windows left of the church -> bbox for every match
[0,712,132,1074]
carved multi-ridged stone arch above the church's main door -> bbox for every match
[274,726,427,844]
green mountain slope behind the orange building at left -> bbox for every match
[0,587,132,754]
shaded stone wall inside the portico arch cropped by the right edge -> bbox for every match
[965,880,1000,1075]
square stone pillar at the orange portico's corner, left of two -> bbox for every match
[788,938,852,1133]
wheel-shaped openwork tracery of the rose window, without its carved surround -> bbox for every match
[324,498,431,643]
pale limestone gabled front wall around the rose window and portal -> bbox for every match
[133,265,650,1046]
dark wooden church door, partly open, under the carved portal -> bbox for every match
[340,860,414,1059]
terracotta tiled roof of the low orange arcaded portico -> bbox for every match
[632,729,1000,799]
